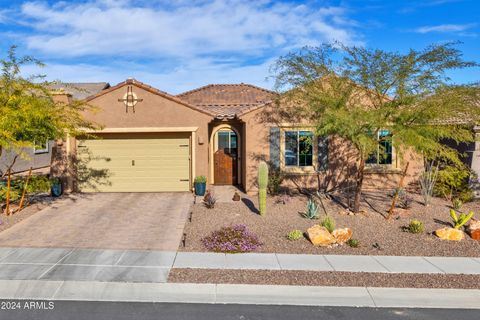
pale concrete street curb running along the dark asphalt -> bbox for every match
[0,280,480,309]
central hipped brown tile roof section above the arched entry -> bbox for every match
[177,83,275,117]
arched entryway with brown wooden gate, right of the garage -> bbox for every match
[210,124,241,185]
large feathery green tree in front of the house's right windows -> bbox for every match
[272,43,480,211]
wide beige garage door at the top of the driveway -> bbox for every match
[77,133,190,192]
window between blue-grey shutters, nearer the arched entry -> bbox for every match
[285,131,313,167]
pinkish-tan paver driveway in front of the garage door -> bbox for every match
[0,193,193,251]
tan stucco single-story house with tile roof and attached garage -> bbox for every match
[52,79,423,193]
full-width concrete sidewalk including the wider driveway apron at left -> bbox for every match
[0,248,480,283]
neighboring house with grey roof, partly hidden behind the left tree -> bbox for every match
[0,82,110,178]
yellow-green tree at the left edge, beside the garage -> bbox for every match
[0,46,95,177]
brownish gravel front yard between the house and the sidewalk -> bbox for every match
[179,192,480,257]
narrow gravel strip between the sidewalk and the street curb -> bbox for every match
[168,269,480,289]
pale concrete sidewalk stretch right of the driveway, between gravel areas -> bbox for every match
[173,252,480,274]
